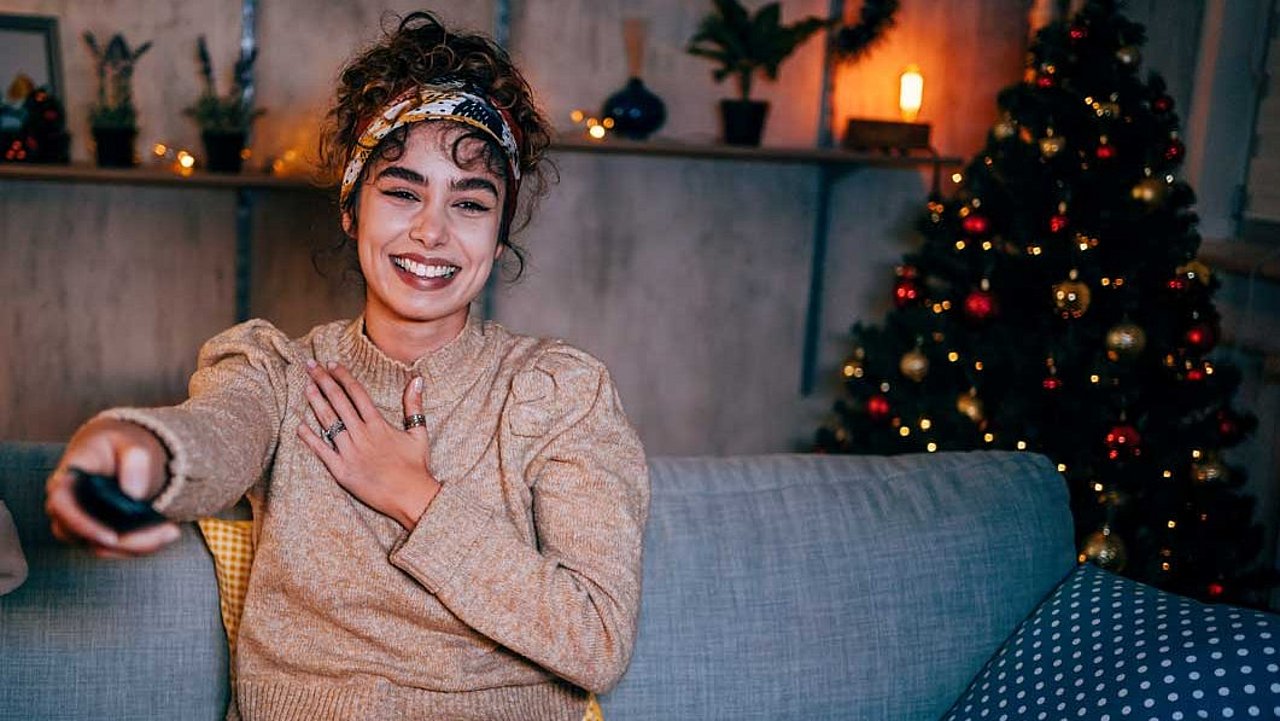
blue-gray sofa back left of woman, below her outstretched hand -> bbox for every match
[0,443,228,721]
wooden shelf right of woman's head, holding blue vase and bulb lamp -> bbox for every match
[552,138,964,168]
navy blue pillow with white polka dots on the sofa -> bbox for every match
[943,565,1280,721]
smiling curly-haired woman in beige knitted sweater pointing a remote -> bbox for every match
[47,13,649,721]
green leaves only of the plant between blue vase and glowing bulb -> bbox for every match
[686,0,832,100]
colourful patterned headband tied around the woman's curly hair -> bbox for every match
[339,81,520,214]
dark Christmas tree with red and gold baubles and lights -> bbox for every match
[817,0,1272,606]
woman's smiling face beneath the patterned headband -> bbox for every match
[343,122,506,332]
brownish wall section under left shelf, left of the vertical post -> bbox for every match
[0,181,234,441]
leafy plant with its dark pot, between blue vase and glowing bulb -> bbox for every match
[687,0,832,145]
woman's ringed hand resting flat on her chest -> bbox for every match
[298,361,440,530]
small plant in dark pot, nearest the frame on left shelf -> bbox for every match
[84,32,151,168]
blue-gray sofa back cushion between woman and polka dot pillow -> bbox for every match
[602,453,1075,721]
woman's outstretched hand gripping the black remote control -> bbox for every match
[45,419,179,558]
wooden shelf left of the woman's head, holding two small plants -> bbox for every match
[0,163,319,190]
